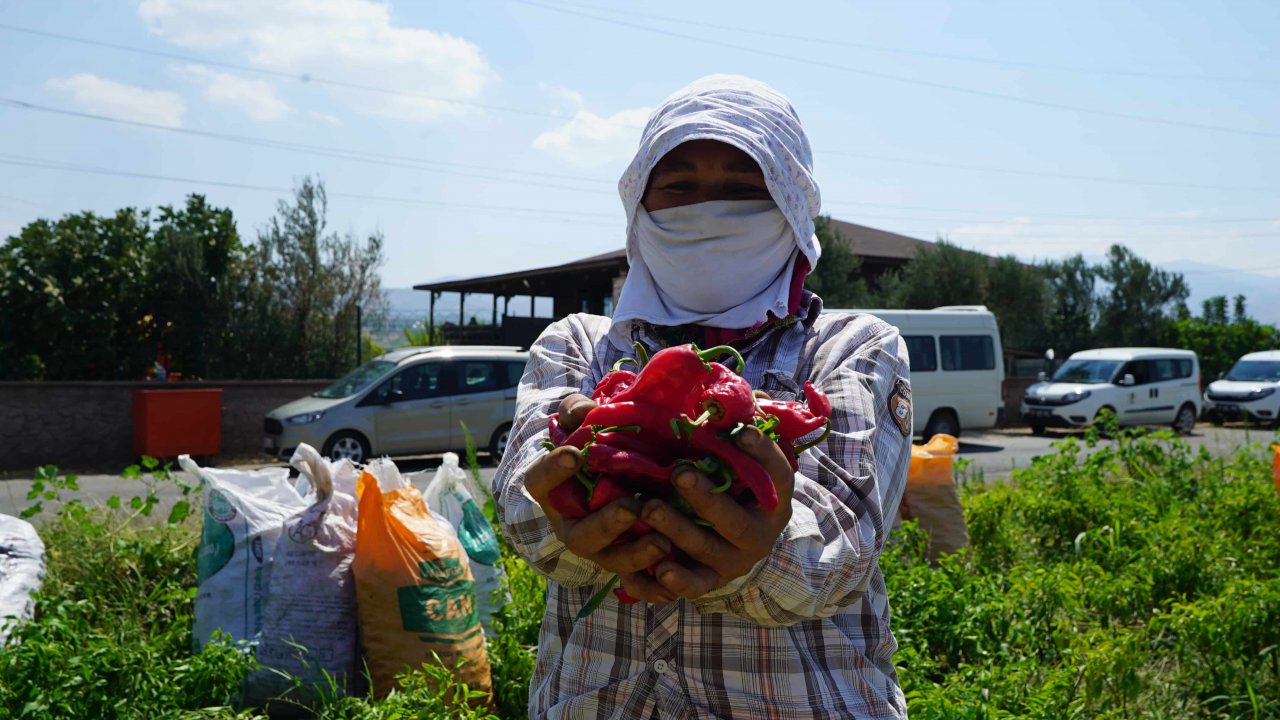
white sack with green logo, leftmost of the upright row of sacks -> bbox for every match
[178,455,306,652]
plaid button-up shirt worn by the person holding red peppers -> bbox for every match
[494,293,911,720]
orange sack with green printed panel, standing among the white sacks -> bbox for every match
[352,461,492,697]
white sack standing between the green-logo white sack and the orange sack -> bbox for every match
[246,445,358,717]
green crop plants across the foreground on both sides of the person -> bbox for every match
[0,433,1280,720]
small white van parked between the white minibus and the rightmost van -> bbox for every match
[1021,347,1201,434]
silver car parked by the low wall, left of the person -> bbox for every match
[262,346,529,462]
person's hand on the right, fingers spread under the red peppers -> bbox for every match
[622,428,795,598]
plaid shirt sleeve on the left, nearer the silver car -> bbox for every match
[493,315,607,587]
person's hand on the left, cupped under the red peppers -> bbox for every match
[525,395,676,602]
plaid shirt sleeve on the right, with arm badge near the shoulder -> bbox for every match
[695,315,911,626]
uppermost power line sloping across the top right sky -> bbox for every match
[509,0,1280,138]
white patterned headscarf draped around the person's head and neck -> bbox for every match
[613,74,822,343]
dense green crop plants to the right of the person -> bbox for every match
[882,430,1280,719]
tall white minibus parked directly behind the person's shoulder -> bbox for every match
[829,305,1005,439]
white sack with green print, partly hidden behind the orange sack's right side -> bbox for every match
[422,452,507,637]
